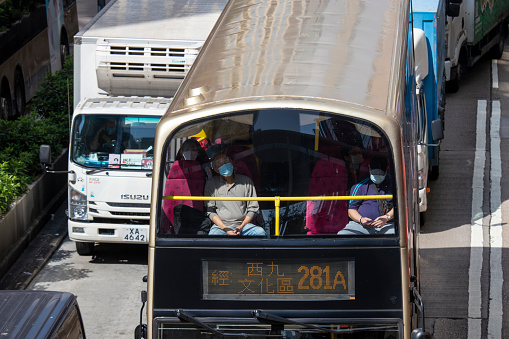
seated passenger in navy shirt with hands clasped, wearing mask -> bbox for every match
[338,156,394,235]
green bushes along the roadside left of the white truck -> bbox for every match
[0,57,73,215]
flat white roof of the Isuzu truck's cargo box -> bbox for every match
[76,0,227,41]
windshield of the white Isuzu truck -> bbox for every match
[71,115,160,170]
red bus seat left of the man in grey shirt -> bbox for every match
[163,160,205,234]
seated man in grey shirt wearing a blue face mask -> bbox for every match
[205,153,265,236]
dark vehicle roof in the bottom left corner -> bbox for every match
[0,290,76,339]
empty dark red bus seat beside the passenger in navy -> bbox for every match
[306,158,348,234]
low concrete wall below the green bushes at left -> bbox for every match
[0,150,68,277]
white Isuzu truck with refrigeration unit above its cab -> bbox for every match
[41,0,227,255]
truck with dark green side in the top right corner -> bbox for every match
[445,0,509,92]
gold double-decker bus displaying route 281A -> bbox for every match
[138,0,429,339]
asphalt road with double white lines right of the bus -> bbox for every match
[420,48,509,339]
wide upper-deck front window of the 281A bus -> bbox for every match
[158,109,397,237]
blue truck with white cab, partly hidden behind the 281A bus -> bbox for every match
[412,0,448,222]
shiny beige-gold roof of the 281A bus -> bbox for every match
[170,0,409,115]
